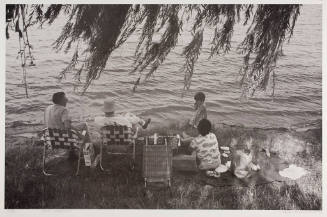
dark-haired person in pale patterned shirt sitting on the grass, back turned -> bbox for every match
[182,119,221,178]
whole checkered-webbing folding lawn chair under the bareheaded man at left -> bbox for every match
[42,128,82,176]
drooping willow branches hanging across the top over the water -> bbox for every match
[6,5,301,94]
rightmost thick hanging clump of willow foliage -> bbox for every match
[241,5,300,95]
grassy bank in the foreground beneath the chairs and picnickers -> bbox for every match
[5,126,322,210]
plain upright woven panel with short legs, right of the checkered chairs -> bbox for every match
[143,138,172,187]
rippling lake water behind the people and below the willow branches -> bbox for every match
[5,5,322,131]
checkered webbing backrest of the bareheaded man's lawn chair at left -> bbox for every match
[43,128,79,149]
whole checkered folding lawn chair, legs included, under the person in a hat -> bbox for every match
[100,125,138,171]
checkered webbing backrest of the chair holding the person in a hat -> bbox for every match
[101,125,133,146]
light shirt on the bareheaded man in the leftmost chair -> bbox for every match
[44,104,71,129]
